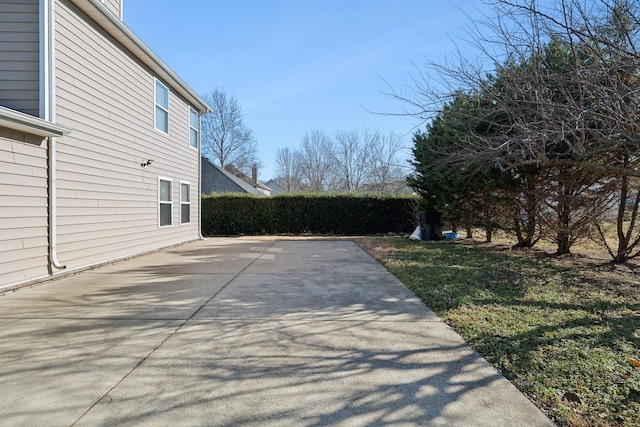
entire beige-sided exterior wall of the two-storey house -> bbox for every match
[0,0,207,290]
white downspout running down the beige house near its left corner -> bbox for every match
[40,0,67,270]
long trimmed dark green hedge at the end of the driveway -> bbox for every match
[202,193,418,236]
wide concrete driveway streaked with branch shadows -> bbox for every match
[0,239,553,427]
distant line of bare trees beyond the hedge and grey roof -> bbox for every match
[201,89,410,193]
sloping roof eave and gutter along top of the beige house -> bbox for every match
[70,0,211,113]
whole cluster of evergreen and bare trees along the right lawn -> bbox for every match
[402,0,640,262]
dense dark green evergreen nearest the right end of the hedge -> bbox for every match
[408,92,509,241]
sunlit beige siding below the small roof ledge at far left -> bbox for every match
[0,127,48,288]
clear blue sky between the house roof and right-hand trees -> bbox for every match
[124,0,486,181]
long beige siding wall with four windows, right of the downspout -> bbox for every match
[56,1,198,268]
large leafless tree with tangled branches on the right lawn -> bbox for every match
[400,0,640,261]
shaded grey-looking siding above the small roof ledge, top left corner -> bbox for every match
[0,0,40,116]
